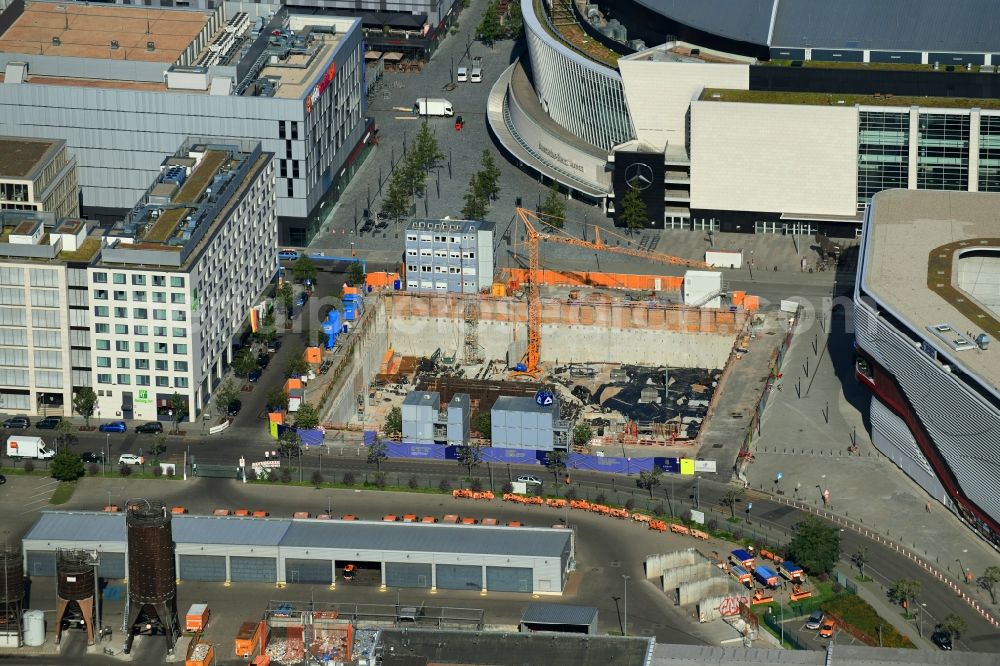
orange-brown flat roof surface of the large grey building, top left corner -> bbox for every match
[0,2,210,63]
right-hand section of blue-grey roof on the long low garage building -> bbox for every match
[281,520,570,557]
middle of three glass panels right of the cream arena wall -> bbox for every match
[917,113,969,190]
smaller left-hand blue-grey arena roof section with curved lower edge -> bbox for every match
[637,0,776,44]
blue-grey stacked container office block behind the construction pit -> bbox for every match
[405,219,496,294]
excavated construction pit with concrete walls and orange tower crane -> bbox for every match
[325,209,763,455]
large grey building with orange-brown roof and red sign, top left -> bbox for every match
[0,1,374,245]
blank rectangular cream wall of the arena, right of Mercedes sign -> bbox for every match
[691,101,858,215]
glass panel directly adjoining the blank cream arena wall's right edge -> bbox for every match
[858,111,910,210]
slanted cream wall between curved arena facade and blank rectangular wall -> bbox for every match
[618,56,750,152]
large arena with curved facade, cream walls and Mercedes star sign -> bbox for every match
[488,0,1000,237]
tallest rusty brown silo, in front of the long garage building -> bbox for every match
[125,499,180,654]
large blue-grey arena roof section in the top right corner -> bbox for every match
[768,0,1000,52]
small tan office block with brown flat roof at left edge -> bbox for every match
[0,136,80,218]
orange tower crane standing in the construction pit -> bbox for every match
[517,208,712,373]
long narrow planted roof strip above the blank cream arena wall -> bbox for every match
[700,88,1000,109]
